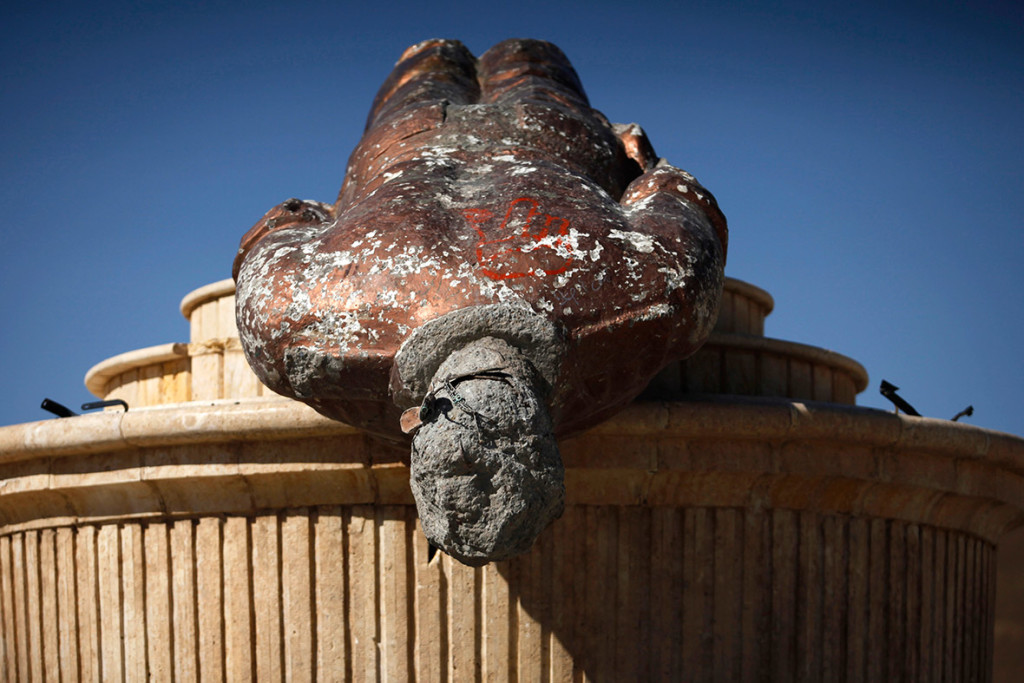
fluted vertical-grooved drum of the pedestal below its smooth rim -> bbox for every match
[0,506,994,681]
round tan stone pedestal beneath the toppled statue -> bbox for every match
[0,276,1024,681]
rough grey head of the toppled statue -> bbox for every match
[411,337,565,565]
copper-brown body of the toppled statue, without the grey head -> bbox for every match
[234,40,726,438]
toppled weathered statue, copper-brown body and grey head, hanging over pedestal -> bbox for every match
[233,40,727,565]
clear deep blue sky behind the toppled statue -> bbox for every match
[0,1,1024,434]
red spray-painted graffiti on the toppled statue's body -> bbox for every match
[462,197,572,280]
